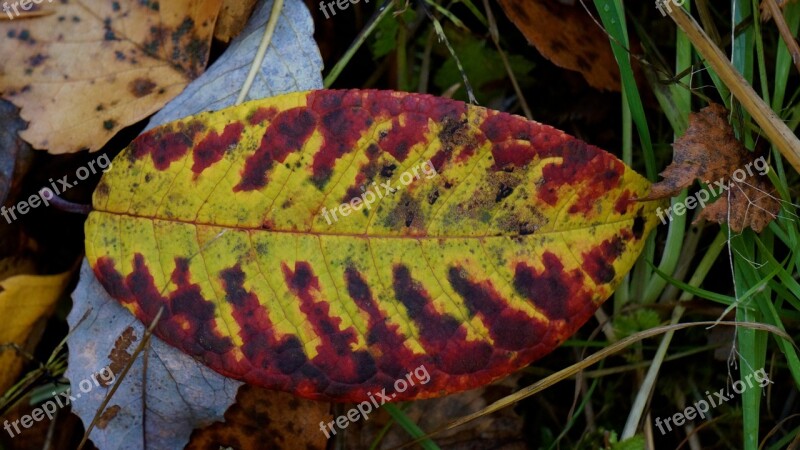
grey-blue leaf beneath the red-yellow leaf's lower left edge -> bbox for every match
[66,260,241,449]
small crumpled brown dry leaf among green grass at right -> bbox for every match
[646,104,781,232]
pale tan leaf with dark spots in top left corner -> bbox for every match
[0,0,222,153]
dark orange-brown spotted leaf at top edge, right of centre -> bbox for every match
[499,0,620,91]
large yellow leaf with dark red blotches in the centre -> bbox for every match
[86,90,658,401]
